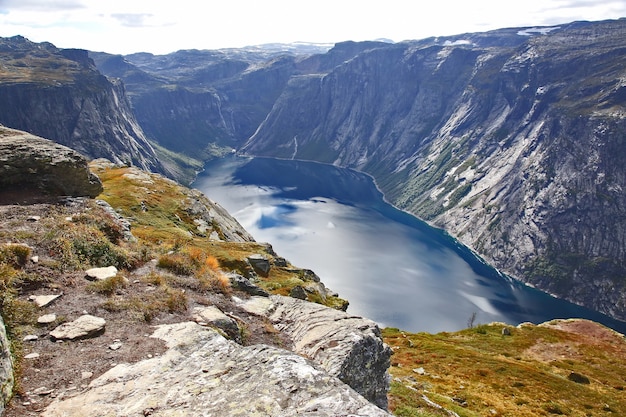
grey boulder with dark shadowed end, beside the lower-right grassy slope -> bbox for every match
[242,295,391,409]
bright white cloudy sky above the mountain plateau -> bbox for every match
[0,0,626,54]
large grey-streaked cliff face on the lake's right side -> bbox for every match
[243,20,626,319]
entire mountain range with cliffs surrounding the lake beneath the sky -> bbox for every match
[0,19,626,320]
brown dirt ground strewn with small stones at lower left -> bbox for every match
[0,202,290,417]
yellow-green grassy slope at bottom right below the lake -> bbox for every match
[383,320,626,417]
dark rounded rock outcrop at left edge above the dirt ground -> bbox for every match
[0,127,102,197]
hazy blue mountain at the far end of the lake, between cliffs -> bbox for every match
[90,42,386,182]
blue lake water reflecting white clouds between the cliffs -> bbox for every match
[193,156,626,333]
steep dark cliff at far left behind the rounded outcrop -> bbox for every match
[0,36,164,173]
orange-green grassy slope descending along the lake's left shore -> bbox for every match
[92,162,345,307]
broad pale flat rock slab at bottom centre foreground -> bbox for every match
[42,322,390,417]
